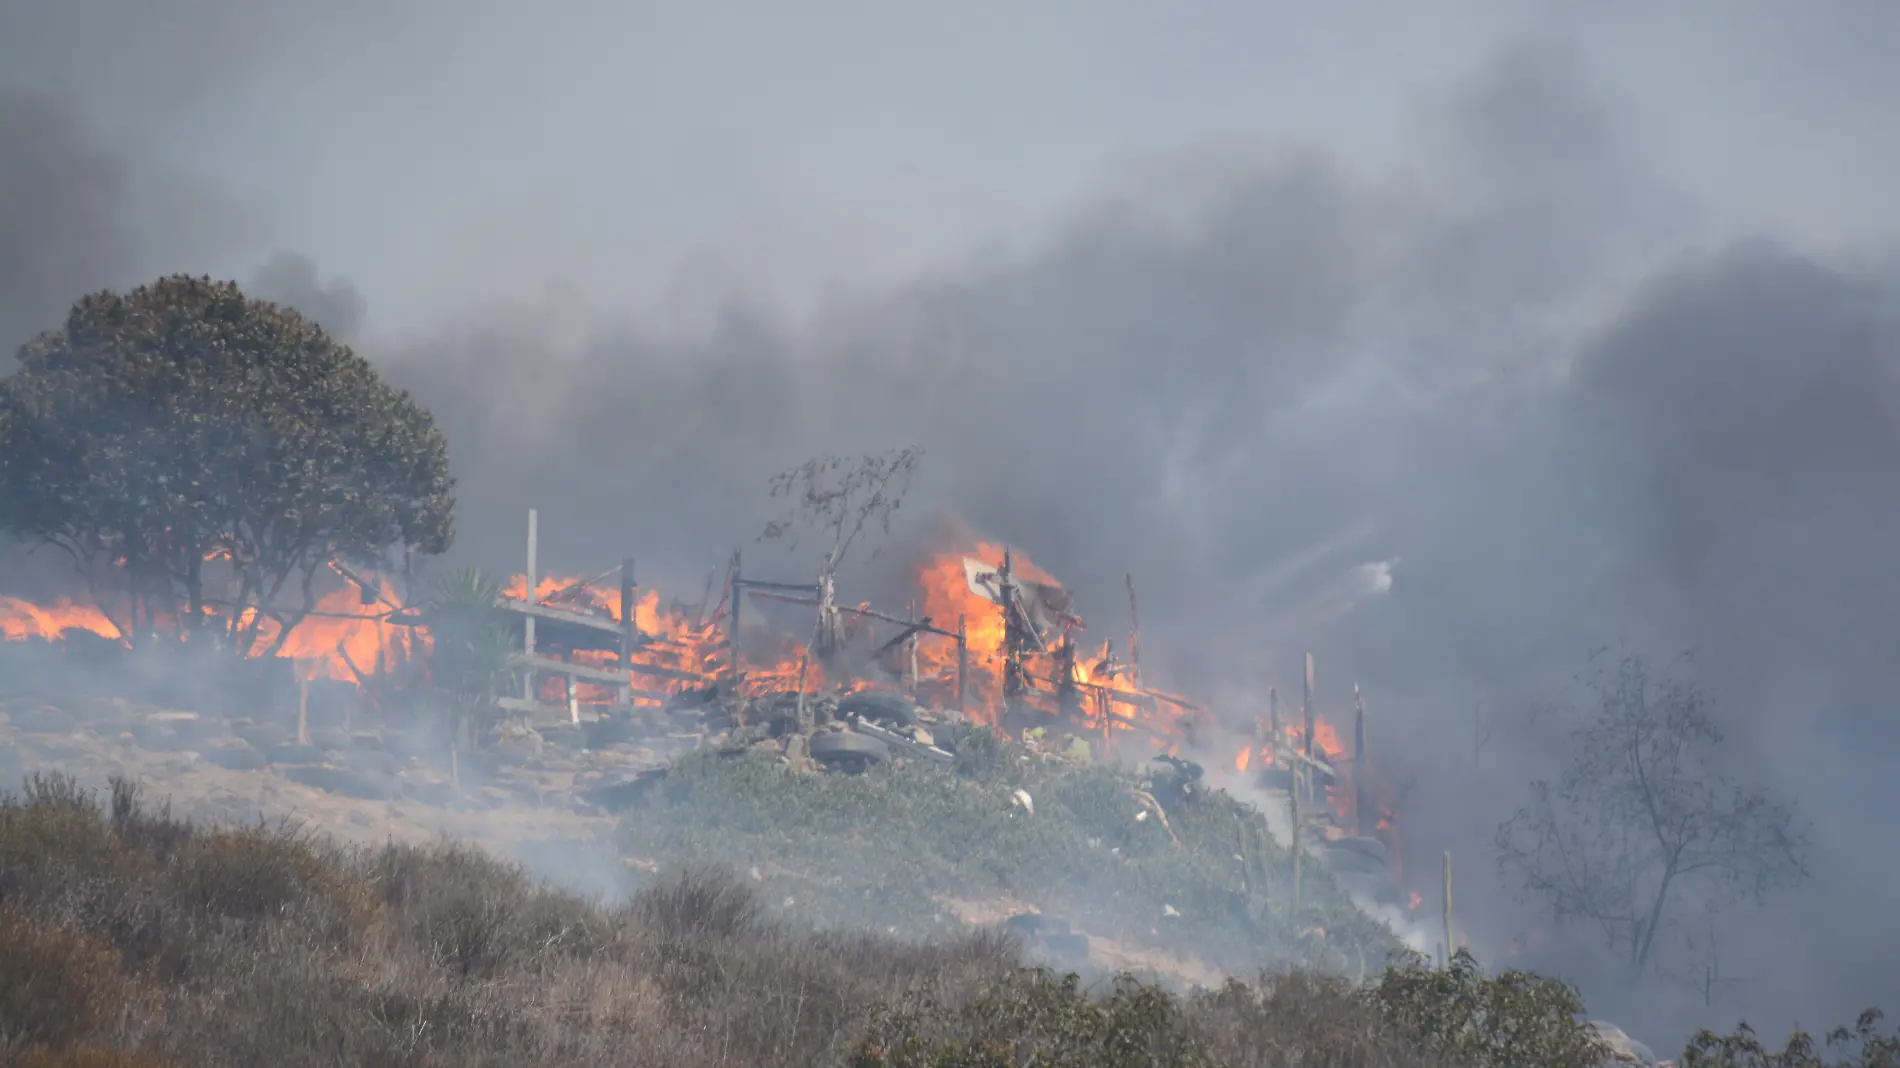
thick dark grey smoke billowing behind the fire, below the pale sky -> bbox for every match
[0,4,1900,1045]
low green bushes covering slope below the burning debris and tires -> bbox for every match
[621,728,1398,975]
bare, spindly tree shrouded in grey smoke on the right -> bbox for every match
[1497,650,1807,975]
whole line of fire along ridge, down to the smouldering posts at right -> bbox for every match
[0,542,1402,889]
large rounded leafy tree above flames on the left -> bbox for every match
[0,276,454,654]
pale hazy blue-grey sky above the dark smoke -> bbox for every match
[0,0,1900,331]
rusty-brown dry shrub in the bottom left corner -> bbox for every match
[0,908,133,1045]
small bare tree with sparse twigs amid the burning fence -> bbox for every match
[758,447,923,661]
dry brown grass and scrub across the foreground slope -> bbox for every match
[0,760,1887,1068]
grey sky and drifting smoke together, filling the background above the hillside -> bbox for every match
[0,0,1900,1045]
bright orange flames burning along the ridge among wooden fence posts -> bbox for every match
[0,542,1343,770]
